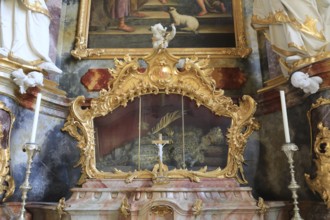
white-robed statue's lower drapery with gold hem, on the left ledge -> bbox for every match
[0,0,62,73]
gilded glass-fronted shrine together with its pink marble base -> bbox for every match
[63,49,264,219]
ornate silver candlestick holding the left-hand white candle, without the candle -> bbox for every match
[18,143,40,220]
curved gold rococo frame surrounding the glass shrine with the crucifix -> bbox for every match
[63,50,259,183]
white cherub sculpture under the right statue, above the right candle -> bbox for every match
[291,71,323,94]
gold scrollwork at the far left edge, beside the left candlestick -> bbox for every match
[0,102,15,201]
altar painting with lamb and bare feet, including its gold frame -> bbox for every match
[72,0,251,59]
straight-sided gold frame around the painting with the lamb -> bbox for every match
[71,0,252,59]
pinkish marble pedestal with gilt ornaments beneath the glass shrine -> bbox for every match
[65,179,264,220]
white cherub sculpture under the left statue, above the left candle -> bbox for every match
[11,69,44,94]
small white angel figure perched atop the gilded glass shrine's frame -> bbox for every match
[151,23,176,49]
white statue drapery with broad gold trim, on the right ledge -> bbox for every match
[252,0,330,68]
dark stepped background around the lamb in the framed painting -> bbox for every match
[88,0,236,48]
